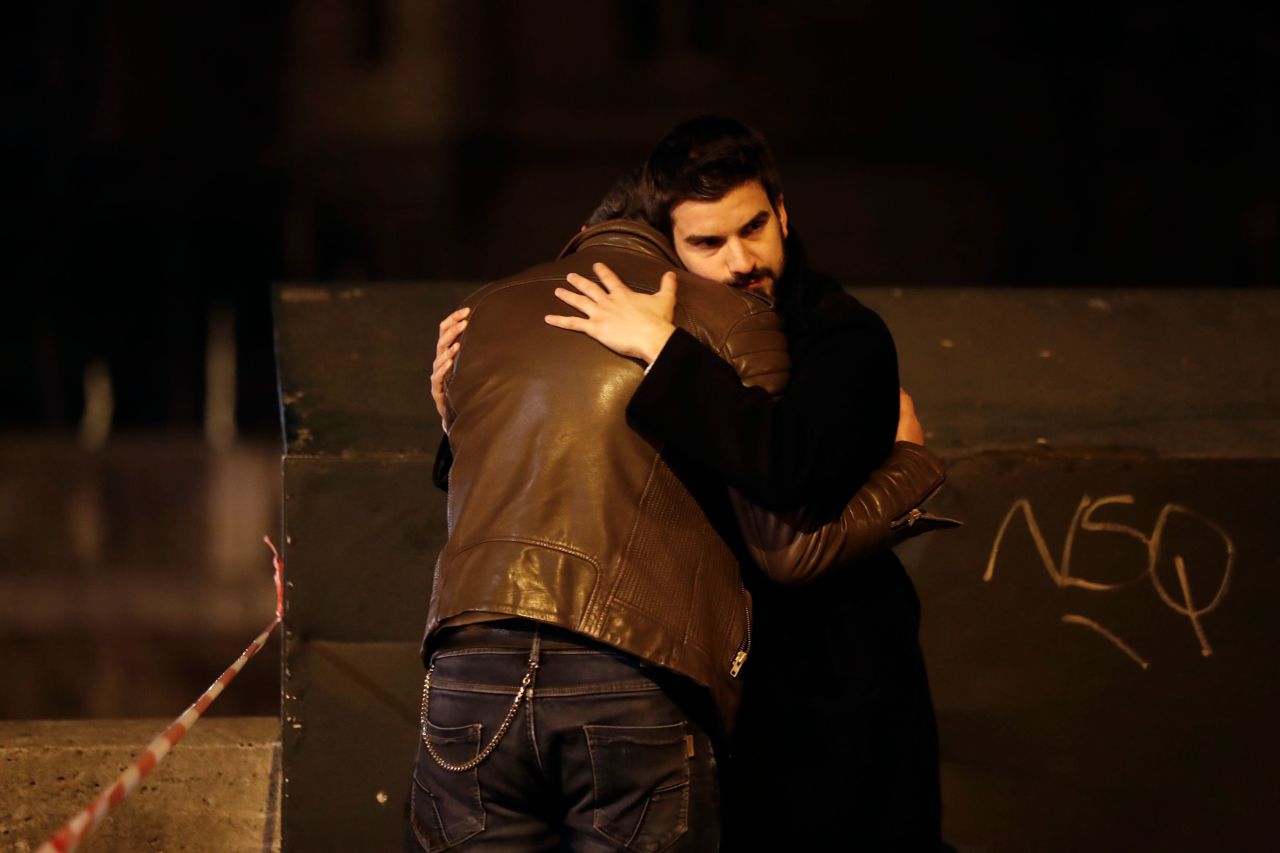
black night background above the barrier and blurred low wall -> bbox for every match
[0,0,1280,437]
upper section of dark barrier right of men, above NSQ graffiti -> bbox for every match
[852,287,1280,459]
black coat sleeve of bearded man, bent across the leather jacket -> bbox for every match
[627,295,899,511]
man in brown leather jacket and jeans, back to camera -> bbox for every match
[412,190,941,850]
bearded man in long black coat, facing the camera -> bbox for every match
[547,117,947,850]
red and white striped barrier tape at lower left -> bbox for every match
[36,537,284,853]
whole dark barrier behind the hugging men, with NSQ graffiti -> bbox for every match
[275,284,1280,853]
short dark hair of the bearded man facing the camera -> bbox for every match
[639,115,782,237]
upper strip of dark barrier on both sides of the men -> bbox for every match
[275,282,1280,459]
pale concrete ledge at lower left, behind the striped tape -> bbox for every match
[0,717,280,853]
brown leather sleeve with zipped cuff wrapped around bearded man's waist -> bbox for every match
[730,442,959,584]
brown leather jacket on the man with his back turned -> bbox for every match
[424,222,941,729]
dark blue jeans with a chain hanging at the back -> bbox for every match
[410,622,719,853]
